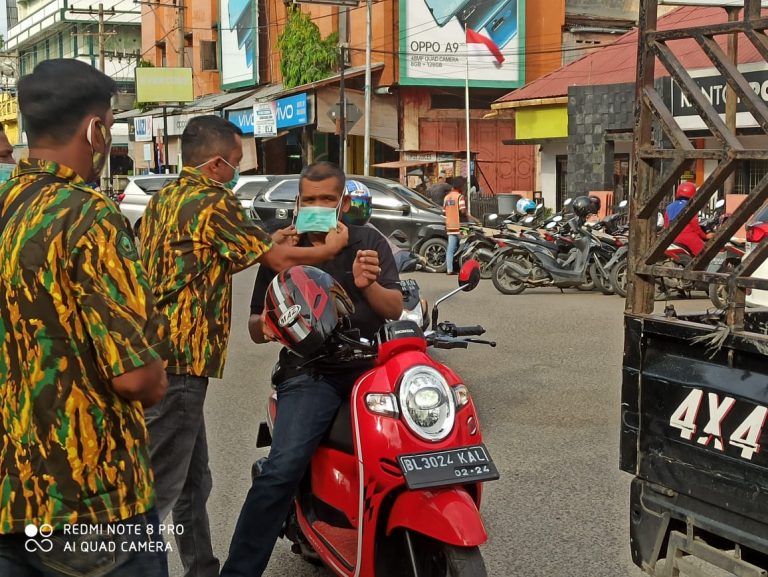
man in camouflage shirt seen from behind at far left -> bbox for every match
[0,59,168,577]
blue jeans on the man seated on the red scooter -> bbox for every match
[221,374,349,577]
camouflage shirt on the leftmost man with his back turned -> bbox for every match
[0,160,165,533]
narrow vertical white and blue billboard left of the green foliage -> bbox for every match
[219,0,259,89]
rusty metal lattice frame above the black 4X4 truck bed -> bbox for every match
[626,0,768,332]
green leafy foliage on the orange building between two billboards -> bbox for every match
[277,7,339,88]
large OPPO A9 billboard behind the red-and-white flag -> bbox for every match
[400,0,525,88]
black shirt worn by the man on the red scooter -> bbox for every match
[251,226,400,380]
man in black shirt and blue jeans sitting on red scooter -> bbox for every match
[221,162,403,577]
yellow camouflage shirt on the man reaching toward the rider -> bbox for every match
[139,167,271,378]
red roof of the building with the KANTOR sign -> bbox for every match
[496,6,765,103]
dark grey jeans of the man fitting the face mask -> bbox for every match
[144,374,219,577]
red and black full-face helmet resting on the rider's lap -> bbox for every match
[264,266,355,357]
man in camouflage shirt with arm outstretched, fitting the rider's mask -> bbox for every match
[139,115,348,577]
